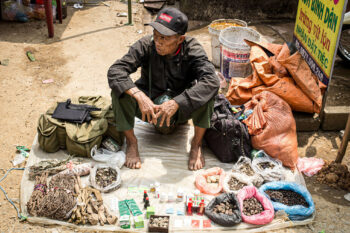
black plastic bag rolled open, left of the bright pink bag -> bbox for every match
[205,193,242,227]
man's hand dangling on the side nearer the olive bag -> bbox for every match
[133,91,157,124]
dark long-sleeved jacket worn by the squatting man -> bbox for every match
[108,36,220,116]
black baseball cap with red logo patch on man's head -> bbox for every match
[149,7,188,36]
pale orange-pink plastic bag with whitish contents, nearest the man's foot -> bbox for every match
[196,167,225,195]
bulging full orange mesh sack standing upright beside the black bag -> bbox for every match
[244,91,298,170]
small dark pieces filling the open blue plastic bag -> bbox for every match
[265,189,309,208]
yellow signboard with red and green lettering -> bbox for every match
[293,0,347,85]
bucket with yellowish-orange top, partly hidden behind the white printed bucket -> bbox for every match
[208,19,247,67]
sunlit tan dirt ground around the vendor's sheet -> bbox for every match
[0,1,350,232]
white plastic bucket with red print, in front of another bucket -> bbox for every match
[219,27,260,81]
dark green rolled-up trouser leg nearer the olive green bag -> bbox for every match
[111,91,141,131]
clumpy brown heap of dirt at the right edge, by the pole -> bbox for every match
[317,161,350,192]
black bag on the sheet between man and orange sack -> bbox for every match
[204,94,252,163]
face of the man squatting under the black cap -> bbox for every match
[153,30,185,56]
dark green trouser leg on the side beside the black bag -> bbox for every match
[178,99,214,129]
